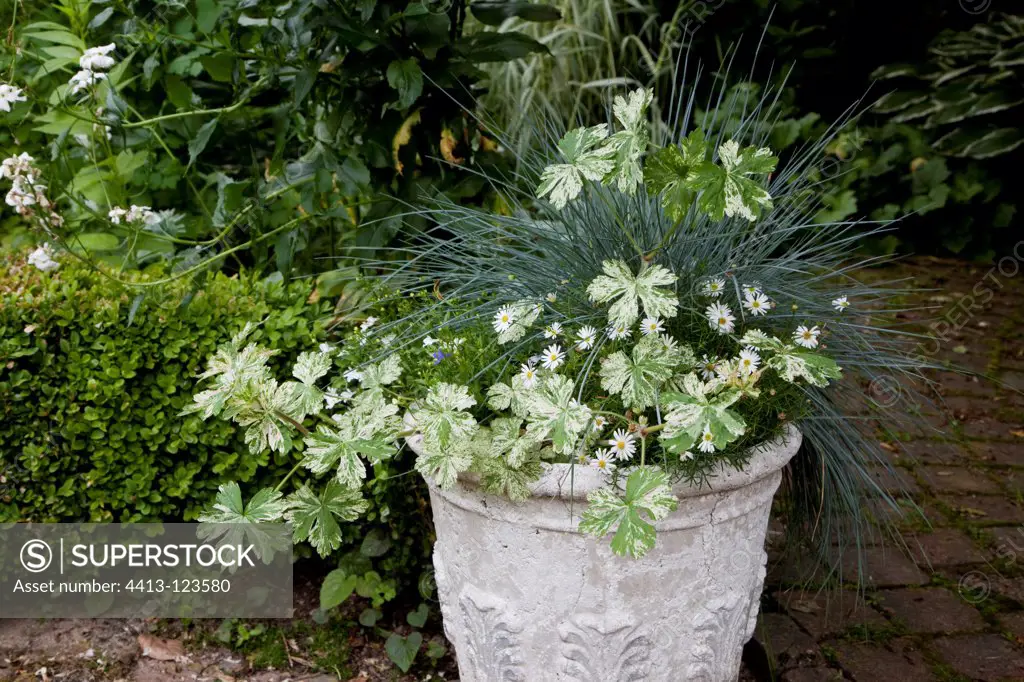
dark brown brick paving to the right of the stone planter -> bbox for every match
[755,259,1024,682]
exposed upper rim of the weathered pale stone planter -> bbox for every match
[406,424,803,502]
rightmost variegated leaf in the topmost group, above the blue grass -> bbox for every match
[694,140,778,222]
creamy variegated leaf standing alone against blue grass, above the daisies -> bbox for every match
[587,260,679,327]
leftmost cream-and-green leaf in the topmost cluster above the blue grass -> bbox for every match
[537,123,614,210]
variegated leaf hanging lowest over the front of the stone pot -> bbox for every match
[580,467,679,559]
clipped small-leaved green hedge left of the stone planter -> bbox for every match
[0,257,325,521]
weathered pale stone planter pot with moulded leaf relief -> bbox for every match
[410,428,801,682]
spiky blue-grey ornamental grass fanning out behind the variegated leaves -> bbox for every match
[346,47,947,581]
